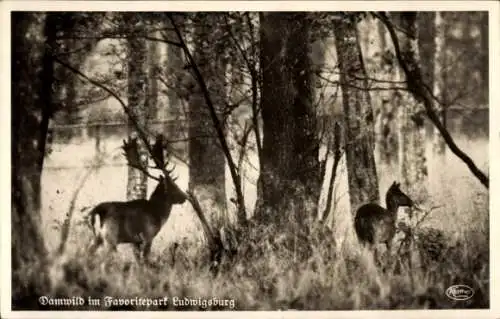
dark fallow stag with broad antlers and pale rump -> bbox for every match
[89,135,187,261]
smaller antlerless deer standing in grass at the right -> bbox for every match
[354,182,413,250]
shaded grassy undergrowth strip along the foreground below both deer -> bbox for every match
[13,210,489,310]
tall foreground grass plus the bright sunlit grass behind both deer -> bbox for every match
[17,134,489,310]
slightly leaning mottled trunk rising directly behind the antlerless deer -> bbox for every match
[334,17,379,213]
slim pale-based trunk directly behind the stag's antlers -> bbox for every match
[124,13,150,200]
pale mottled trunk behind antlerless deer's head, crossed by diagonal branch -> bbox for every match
[398,12,427,200]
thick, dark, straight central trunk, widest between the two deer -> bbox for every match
[255,12,321,223]
